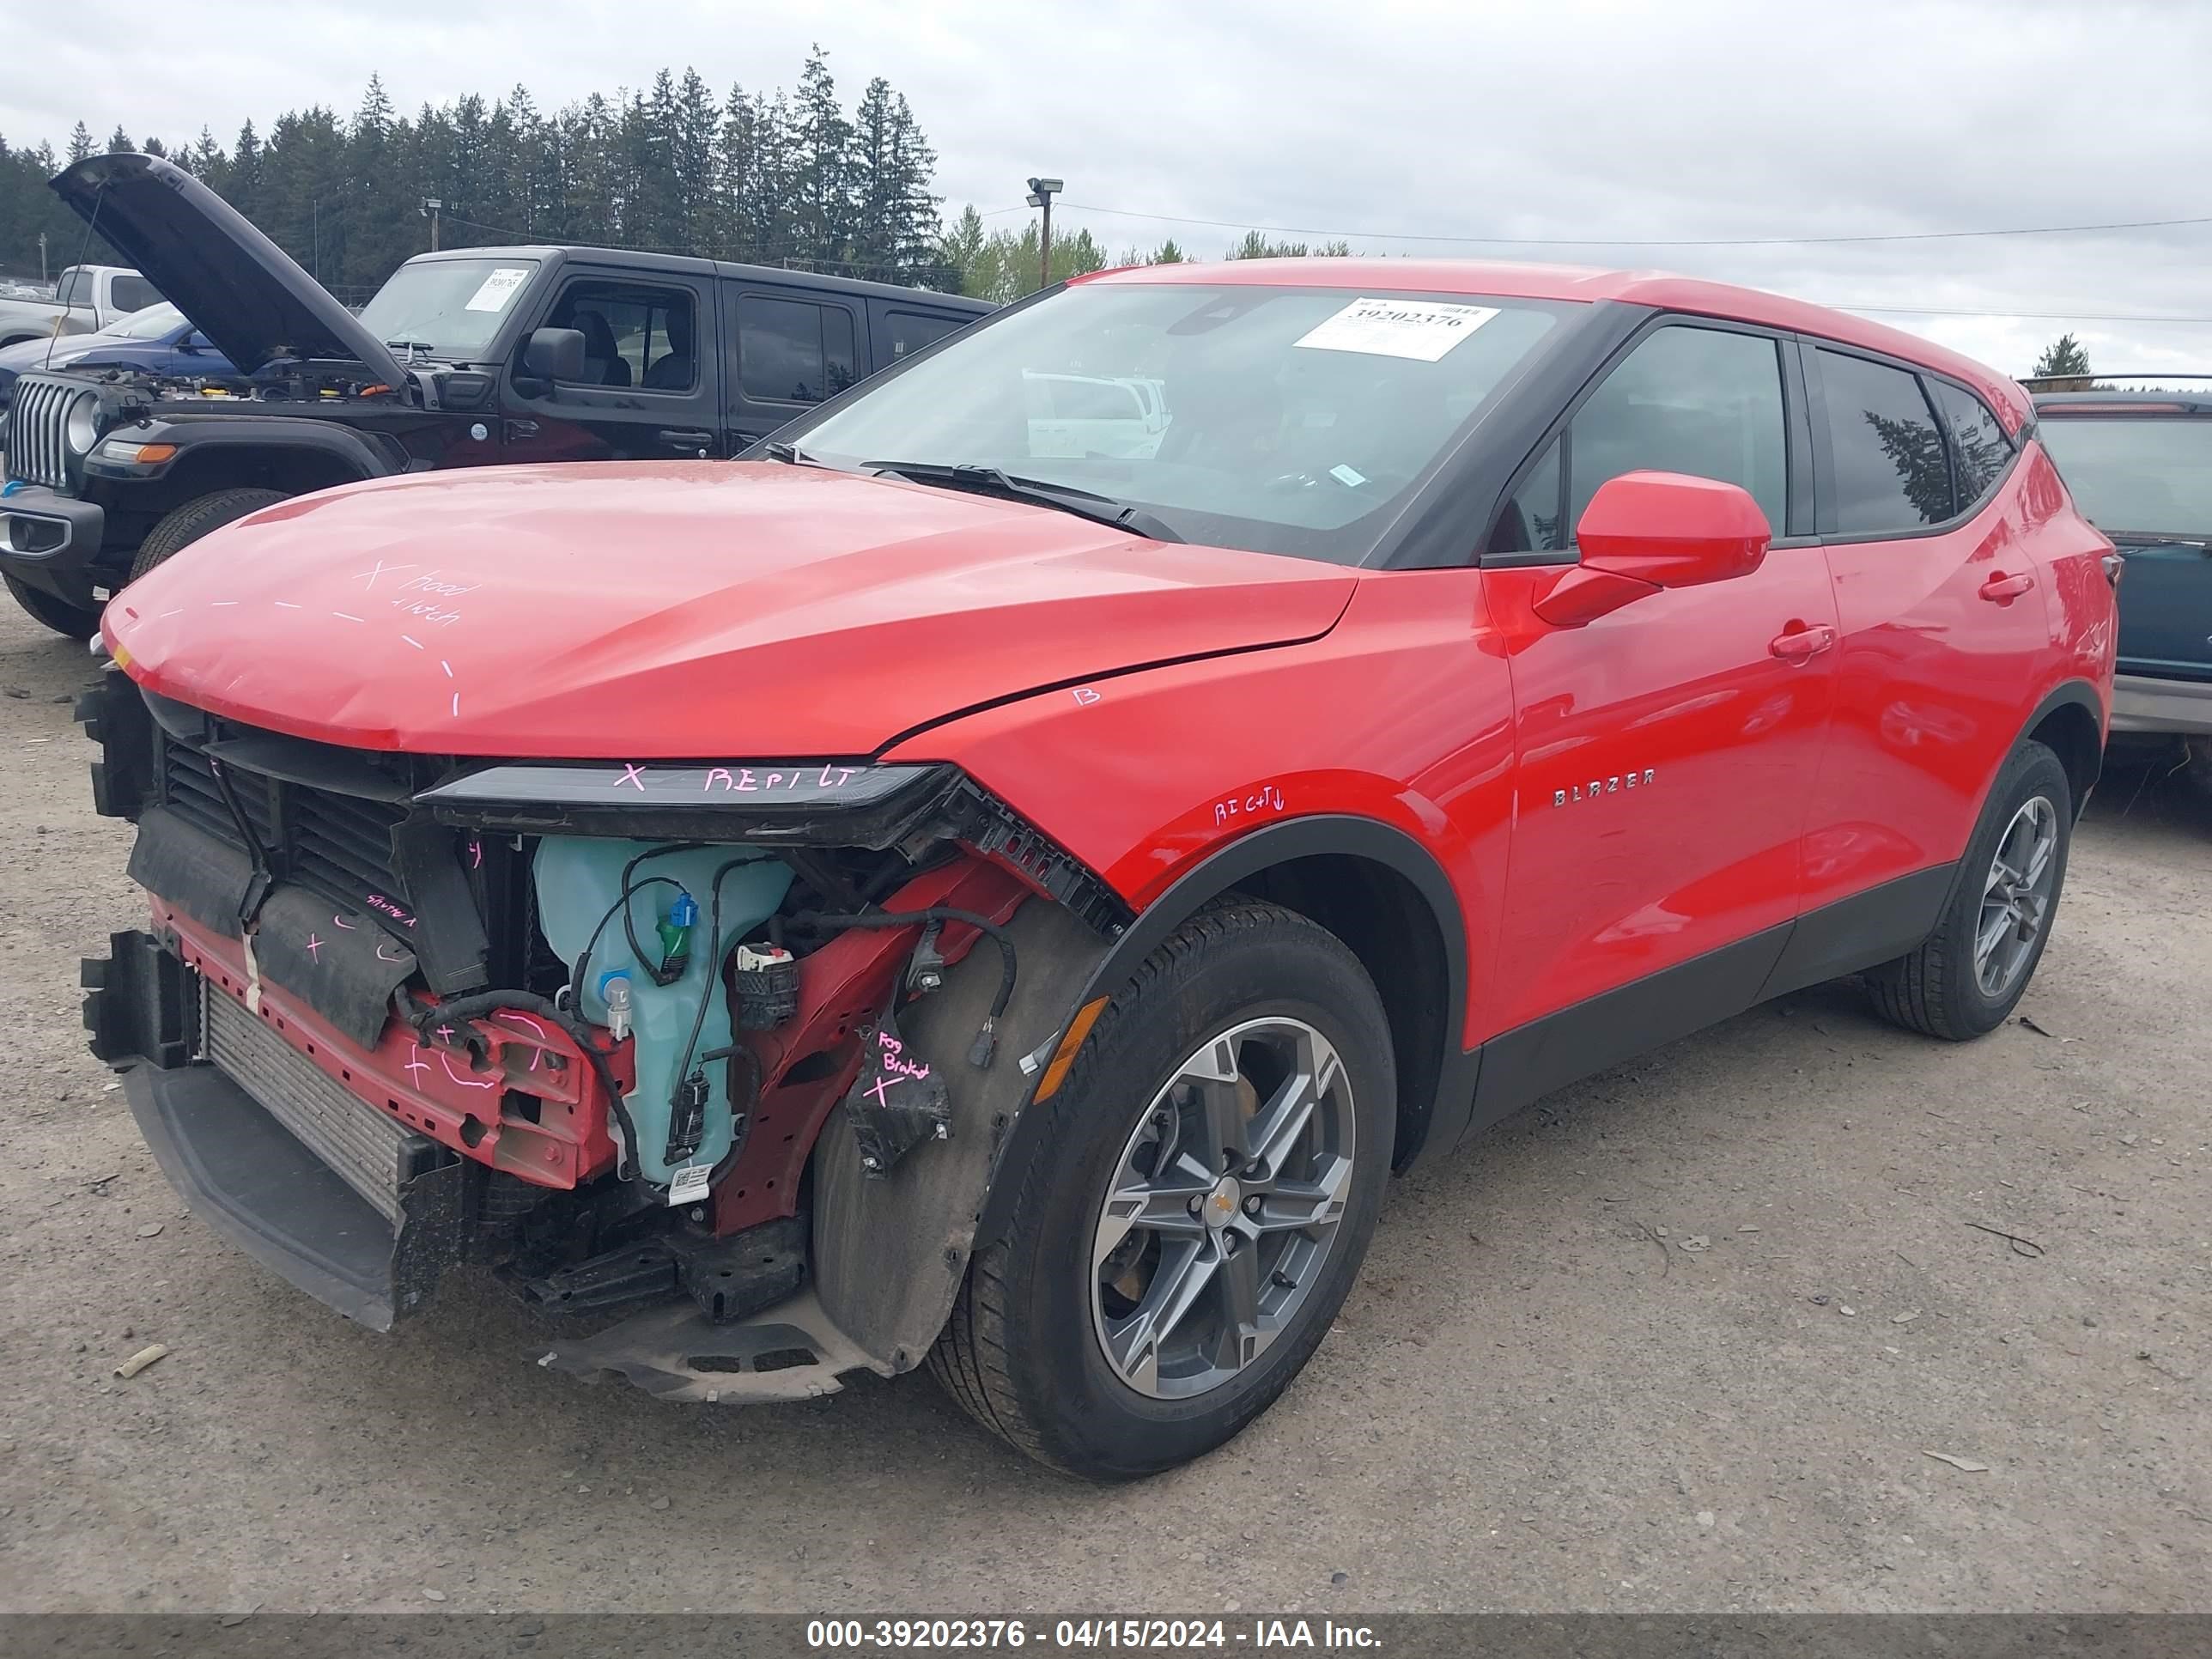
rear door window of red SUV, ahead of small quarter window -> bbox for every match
[1814,349,1951,535]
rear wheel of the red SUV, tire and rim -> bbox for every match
[1867,741,2073,1042]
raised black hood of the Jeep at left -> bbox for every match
[51,153,407,387]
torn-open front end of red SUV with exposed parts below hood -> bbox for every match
[80,671,1128,1401]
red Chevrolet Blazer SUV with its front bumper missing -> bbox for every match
[82,258,2117,1478]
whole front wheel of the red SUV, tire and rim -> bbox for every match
[929,898,1398,1480]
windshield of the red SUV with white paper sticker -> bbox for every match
[785,285,1573,564]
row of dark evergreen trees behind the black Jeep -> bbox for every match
[0,46,946,299]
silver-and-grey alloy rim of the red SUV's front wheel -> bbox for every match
[1091,1018,1356,1401]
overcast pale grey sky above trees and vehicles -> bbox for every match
[0,0,2212,374]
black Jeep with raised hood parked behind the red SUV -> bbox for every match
[0,155,991,639]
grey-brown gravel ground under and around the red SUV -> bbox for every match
[0,606,2212,1613]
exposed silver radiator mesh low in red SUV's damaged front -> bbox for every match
[199,980,427,1225]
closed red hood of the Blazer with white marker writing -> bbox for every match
[106,462,1358,759]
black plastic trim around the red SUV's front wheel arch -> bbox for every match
[975,814,1480,1249]
